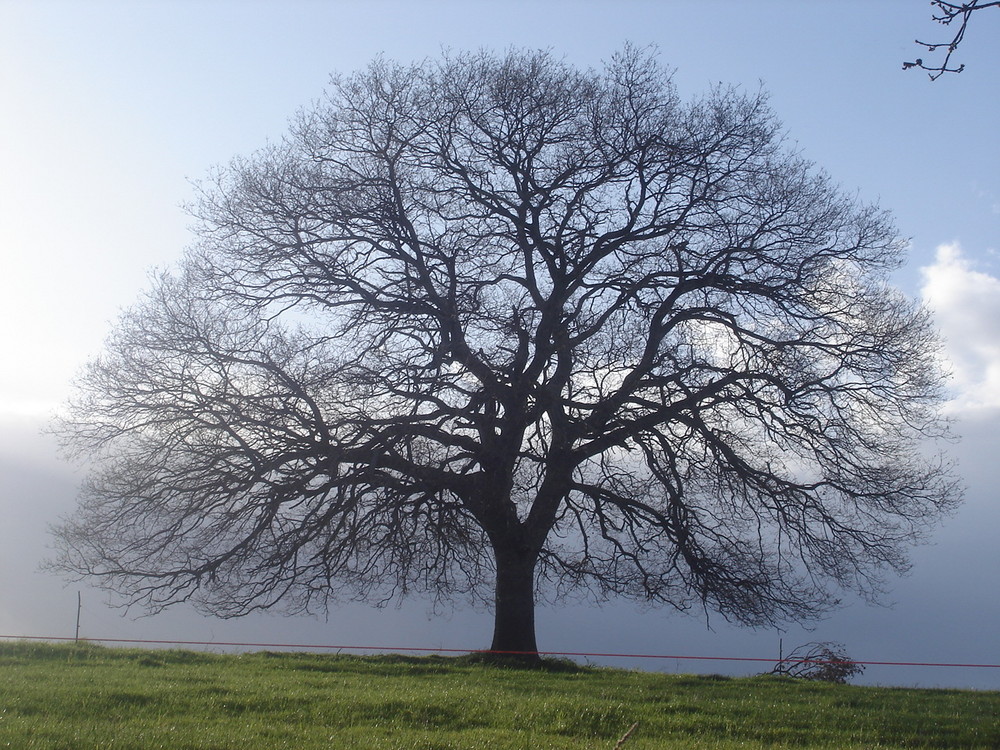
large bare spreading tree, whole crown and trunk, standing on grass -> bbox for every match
[57,49,958,653]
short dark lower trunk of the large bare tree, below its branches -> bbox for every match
[490,551,539,661]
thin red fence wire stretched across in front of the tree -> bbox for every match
[0,635,1000,669]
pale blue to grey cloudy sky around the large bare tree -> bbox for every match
[0,0,1000,689]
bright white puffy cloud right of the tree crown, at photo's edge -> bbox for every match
[920,242,1000,414]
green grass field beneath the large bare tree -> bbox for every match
[0,643,1000,750]
